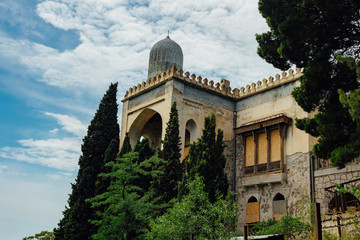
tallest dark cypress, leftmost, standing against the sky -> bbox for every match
[54,83,119,240]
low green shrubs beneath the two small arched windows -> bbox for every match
[254,215,311,239]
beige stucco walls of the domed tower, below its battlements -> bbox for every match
[120,79,233,157]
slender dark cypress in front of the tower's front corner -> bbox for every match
[152,102,183,203]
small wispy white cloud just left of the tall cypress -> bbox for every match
[44,112,87,137]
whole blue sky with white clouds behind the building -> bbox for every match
[0,0,280,240]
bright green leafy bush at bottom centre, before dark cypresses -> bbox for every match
[147,176,237,240]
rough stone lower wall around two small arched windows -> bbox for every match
[236,152,310,230]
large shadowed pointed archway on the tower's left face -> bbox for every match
[129,109,162,149]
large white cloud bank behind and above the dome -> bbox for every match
[0,0,278,100]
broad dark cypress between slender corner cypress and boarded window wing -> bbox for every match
[181,114,229,202]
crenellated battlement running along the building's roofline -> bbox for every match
[124,66,302,100]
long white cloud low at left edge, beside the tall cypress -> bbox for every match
[0,138,81,171]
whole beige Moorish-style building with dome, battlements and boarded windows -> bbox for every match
[121,37,360,230]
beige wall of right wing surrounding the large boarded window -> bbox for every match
[236,82,313,229]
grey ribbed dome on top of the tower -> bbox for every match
[148,36,183,79]
